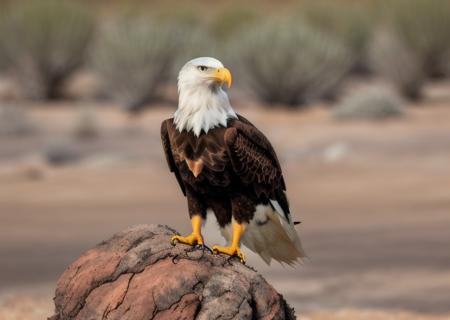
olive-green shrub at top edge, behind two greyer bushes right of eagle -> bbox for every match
[300,0,375,73]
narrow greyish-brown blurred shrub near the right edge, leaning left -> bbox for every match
[370,30,425,100]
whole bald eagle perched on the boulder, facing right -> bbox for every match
[161,57,305,264]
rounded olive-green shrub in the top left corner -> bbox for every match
[0,0,94,99]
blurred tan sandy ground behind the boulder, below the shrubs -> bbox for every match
[0,90,450,320]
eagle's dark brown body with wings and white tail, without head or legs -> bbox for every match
[161,115,305,263]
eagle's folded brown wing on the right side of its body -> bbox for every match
[225,116,289,215]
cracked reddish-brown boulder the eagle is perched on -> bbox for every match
[50,225,295,320]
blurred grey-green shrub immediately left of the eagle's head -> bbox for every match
[93,17,192,111]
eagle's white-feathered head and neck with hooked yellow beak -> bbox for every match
[174,57,237,136]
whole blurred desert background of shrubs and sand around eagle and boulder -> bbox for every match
[0,0,450,320]
